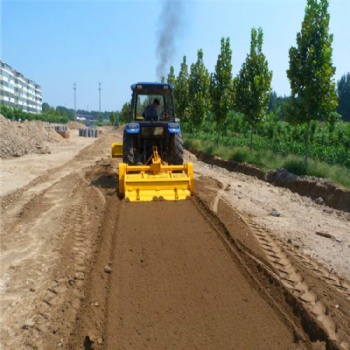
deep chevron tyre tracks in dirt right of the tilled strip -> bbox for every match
[210,180,350,349]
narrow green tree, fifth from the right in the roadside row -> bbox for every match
[174,56,189,124]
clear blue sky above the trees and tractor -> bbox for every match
[0,0,350,111]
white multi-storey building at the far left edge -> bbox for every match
[0,60,42,113]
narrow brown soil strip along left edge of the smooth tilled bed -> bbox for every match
[67,161,120,349]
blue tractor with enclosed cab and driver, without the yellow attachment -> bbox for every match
[123,83,183,165]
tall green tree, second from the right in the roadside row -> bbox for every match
[234,28,272,149]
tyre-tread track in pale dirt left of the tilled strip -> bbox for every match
[22,182,102,348]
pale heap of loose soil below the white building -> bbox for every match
[0,114,69,158]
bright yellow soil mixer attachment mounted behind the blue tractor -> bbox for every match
[112,144,194,202]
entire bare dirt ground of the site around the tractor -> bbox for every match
[0,121,350,350]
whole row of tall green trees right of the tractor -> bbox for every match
[120,0,350,170]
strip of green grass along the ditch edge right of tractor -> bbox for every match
[184,138,350,189]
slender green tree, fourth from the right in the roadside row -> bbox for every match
[188,49,210,134]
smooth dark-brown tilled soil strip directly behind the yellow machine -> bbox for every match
[99,201,294,349]
